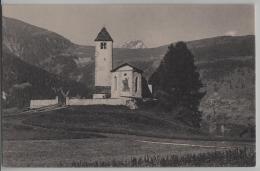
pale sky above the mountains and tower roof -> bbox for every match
[3,4,255,47]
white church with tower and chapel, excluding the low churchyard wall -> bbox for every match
[93,27,143,99]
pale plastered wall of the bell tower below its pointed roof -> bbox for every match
[95,41,113,86]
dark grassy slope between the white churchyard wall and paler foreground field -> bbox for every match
[3,106,251,141]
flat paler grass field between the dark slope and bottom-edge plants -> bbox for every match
[3,134,255,167]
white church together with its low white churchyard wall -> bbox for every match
[30,27,146,109]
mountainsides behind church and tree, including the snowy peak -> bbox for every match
[2,17,255,126]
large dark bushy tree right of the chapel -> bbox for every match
[149,42,205,127]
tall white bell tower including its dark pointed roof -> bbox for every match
[95,27,113,87]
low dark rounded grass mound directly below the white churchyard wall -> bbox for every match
[20,106,201,137]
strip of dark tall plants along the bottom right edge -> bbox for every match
[70,148,255,167]
